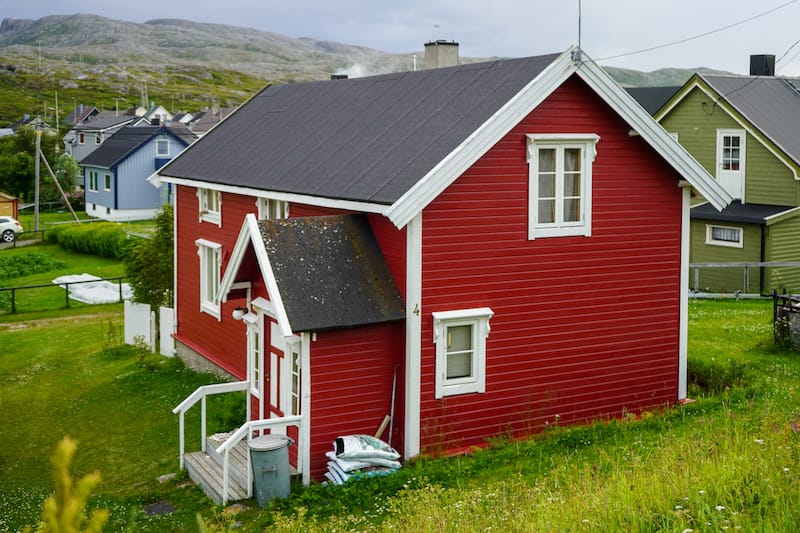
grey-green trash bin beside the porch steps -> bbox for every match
[250,434,294,507]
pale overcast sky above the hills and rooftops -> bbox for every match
[0,0,800,76]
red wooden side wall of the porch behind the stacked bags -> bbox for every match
[311,322,405,479]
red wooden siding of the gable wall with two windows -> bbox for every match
[420,78,681,456]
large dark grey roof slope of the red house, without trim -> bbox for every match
[159,54,559,205]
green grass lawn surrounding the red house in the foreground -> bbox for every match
[0,294,800,531]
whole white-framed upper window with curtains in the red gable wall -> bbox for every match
[528,134,600,239]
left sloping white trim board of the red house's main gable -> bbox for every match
[385,49,576,228]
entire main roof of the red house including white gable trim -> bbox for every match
[151,49,730,227]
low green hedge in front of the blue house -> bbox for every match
[45,222,130,259]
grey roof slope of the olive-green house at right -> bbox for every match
[700,75,800,165]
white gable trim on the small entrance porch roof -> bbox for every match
[219,213,294,337]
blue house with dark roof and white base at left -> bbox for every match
[79,124,196,220]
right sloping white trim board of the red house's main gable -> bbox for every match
[578,59,733,209]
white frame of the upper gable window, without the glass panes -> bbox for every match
[527,133,600,240]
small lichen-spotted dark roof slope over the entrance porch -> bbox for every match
[258,215,405,331]
